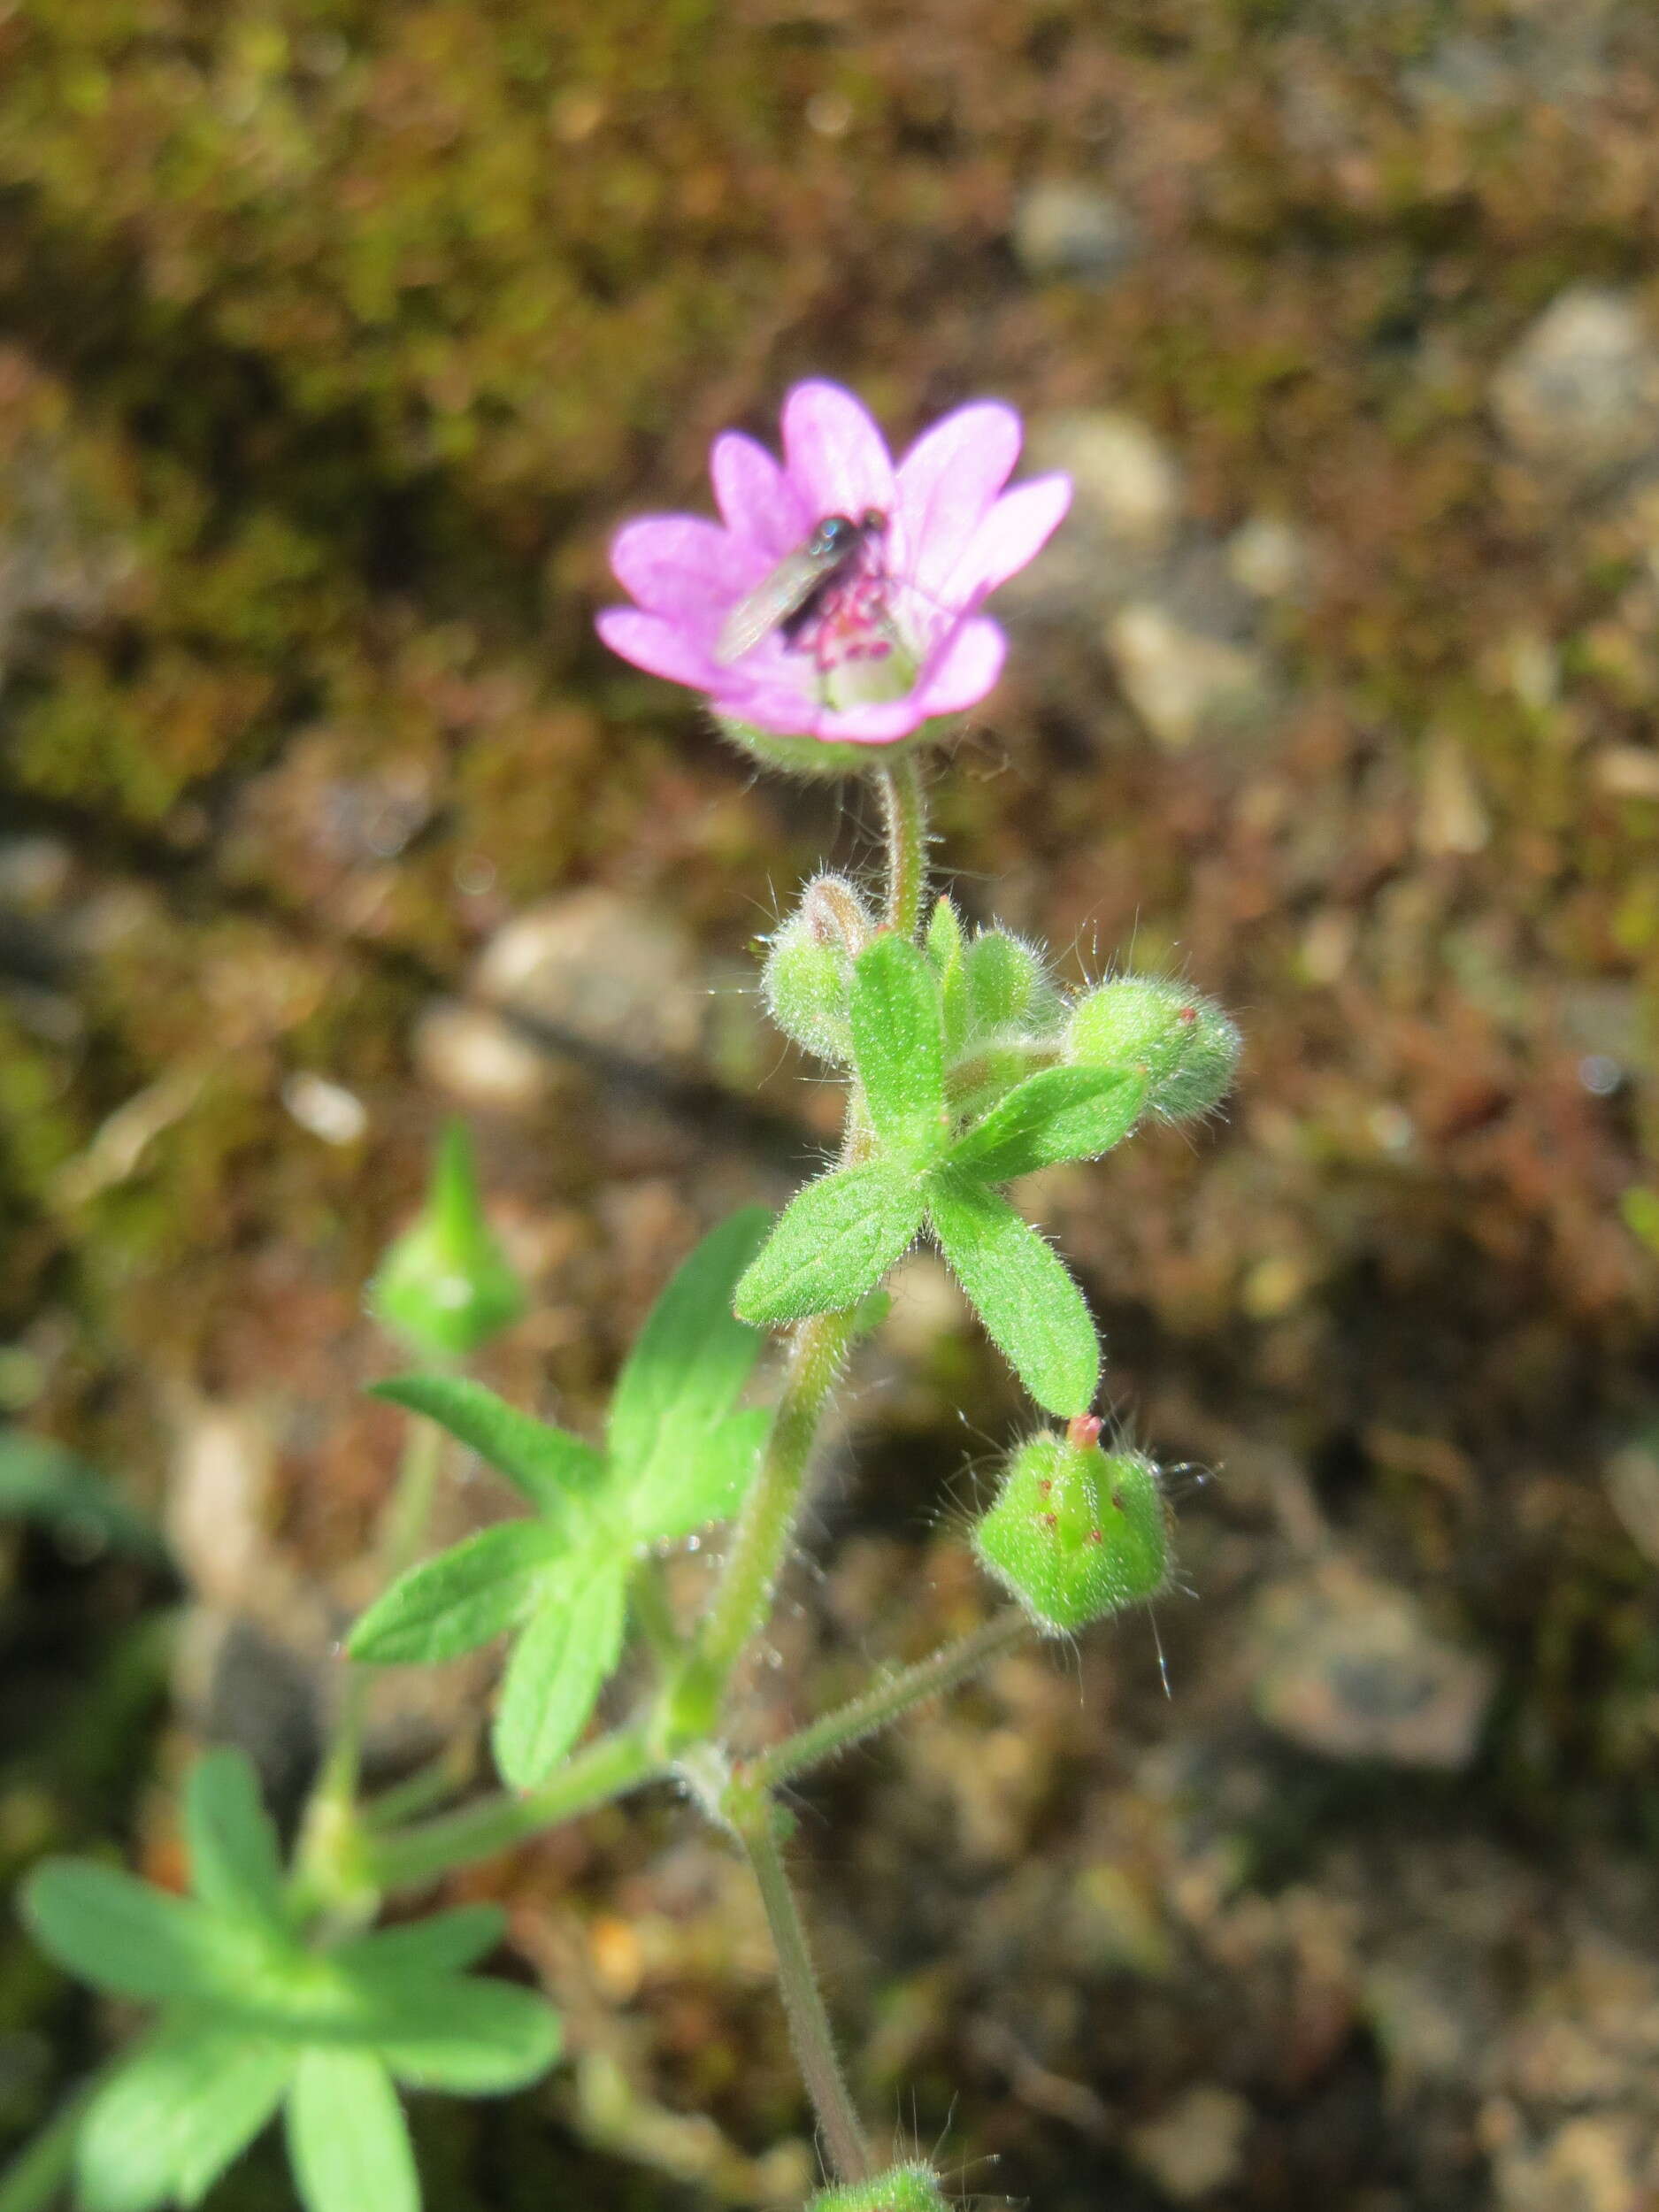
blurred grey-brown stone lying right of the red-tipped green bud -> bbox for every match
[1252,1560,1494,1772]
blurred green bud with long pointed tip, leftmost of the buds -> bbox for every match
[367,1122,525,1361]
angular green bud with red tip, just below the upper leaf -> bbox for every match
[973,1414,1171,1632]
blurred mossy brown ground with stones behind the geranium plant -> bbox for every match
[0,0,1659,2212]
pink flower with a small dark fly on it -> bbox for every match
[600,383,1071,746]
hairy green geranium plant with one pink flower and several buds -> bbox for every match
[9,383,1239,2212]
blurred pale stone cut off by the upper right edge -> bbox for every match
[1491,286,1659,482]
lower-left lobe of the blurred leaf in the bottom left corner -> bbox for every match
[75,2016,295,2212]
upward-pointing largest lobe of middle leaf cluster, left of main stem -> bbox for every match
[609,1206,772,1482]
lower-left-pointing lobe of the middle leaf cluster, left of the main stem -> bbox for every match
[345,1520,571,1666]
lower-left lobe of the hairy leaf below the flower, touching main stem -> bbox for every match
[737,1159,927,1327]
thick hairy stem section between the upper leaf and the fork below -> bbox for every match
[684,1312,854,1725]
